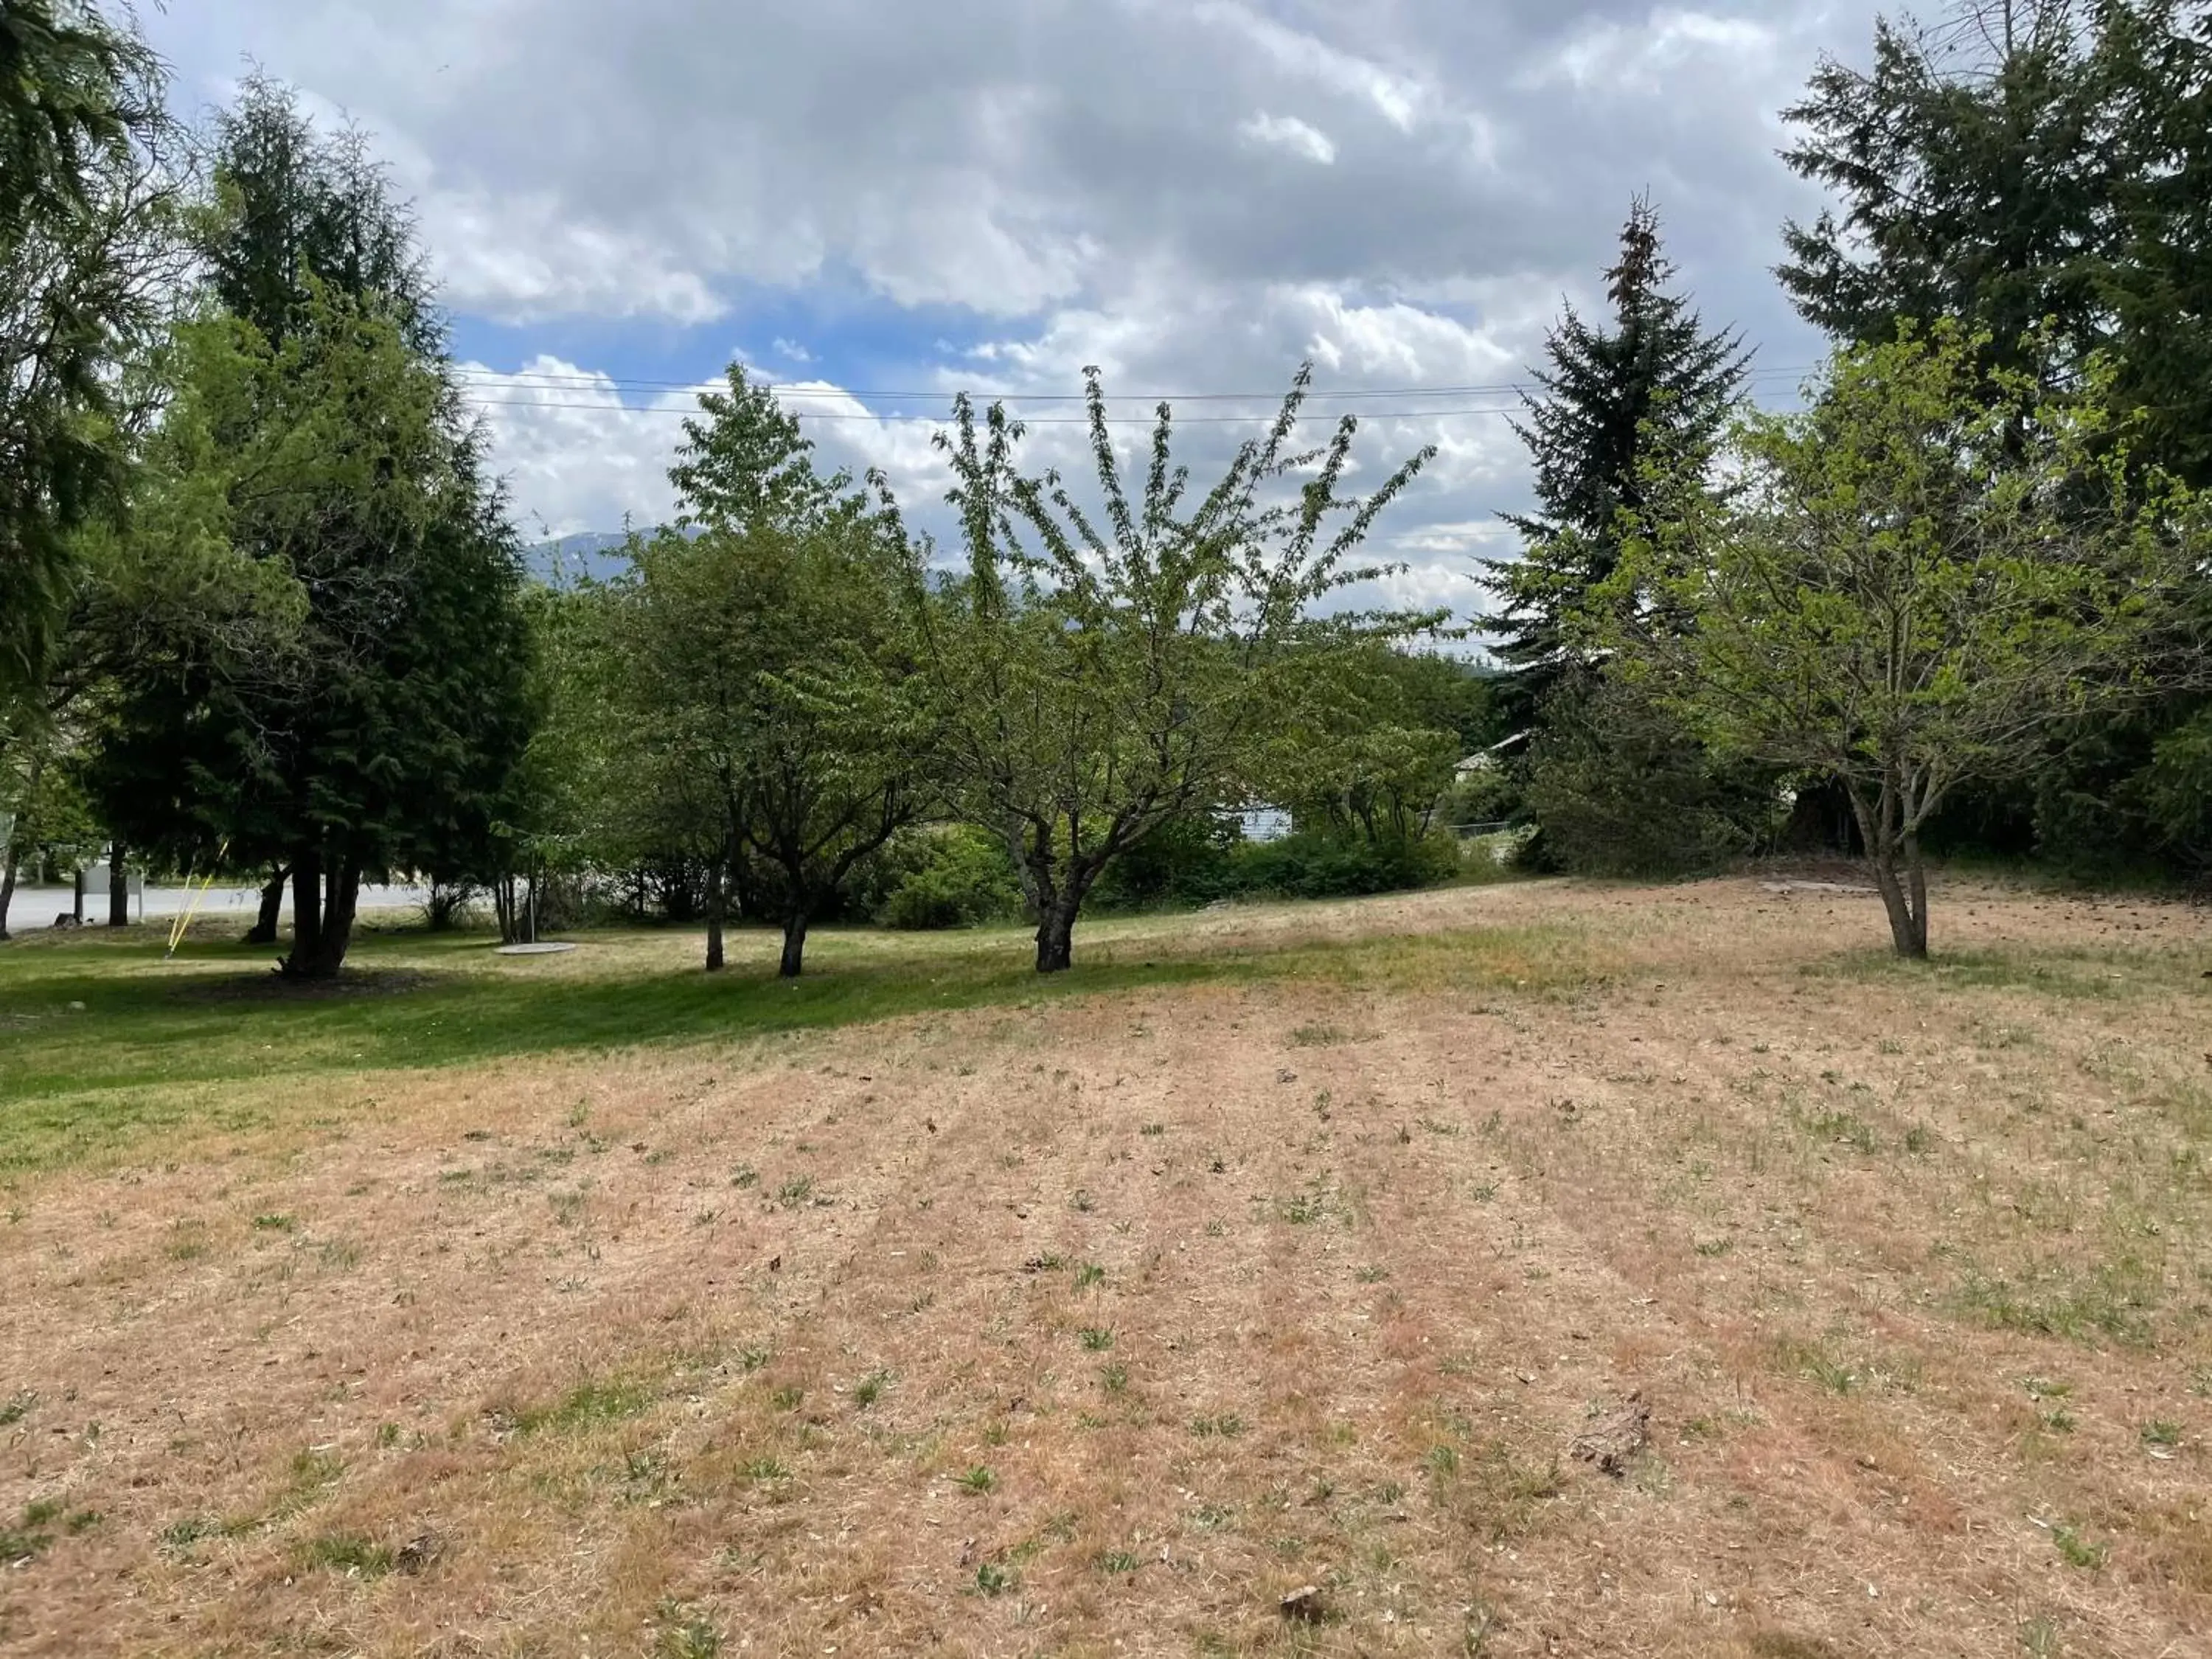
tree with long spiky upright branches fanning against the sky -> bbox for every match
[920,367,1438,973]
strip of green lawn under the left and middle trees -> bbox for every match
[0,918,1588,1172]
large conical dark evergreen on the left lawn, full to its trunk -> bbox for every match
[97,82,531,978]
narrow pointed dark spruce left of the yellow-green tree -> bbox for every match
[1482,197,1750,710]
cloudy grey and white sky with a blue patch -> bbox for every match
[146,0,1874,611]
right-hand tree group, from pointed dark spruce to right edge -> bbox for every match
[1489,0,2212,956]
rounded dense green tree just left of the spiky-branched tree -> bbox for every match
[611,367,931,978]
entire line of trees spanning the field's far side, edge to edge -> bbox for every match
[0,0,2212,978]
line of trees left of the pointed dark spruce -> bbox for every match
[0,0,1478,978]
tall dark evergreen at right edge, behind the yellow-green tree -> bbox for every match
[1778,0,2212,872]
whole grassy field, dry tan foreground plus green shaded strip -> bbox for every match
[0,880,2212,1659]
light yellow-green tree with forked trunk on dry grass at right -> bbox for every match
[1601,325,2201,958]
